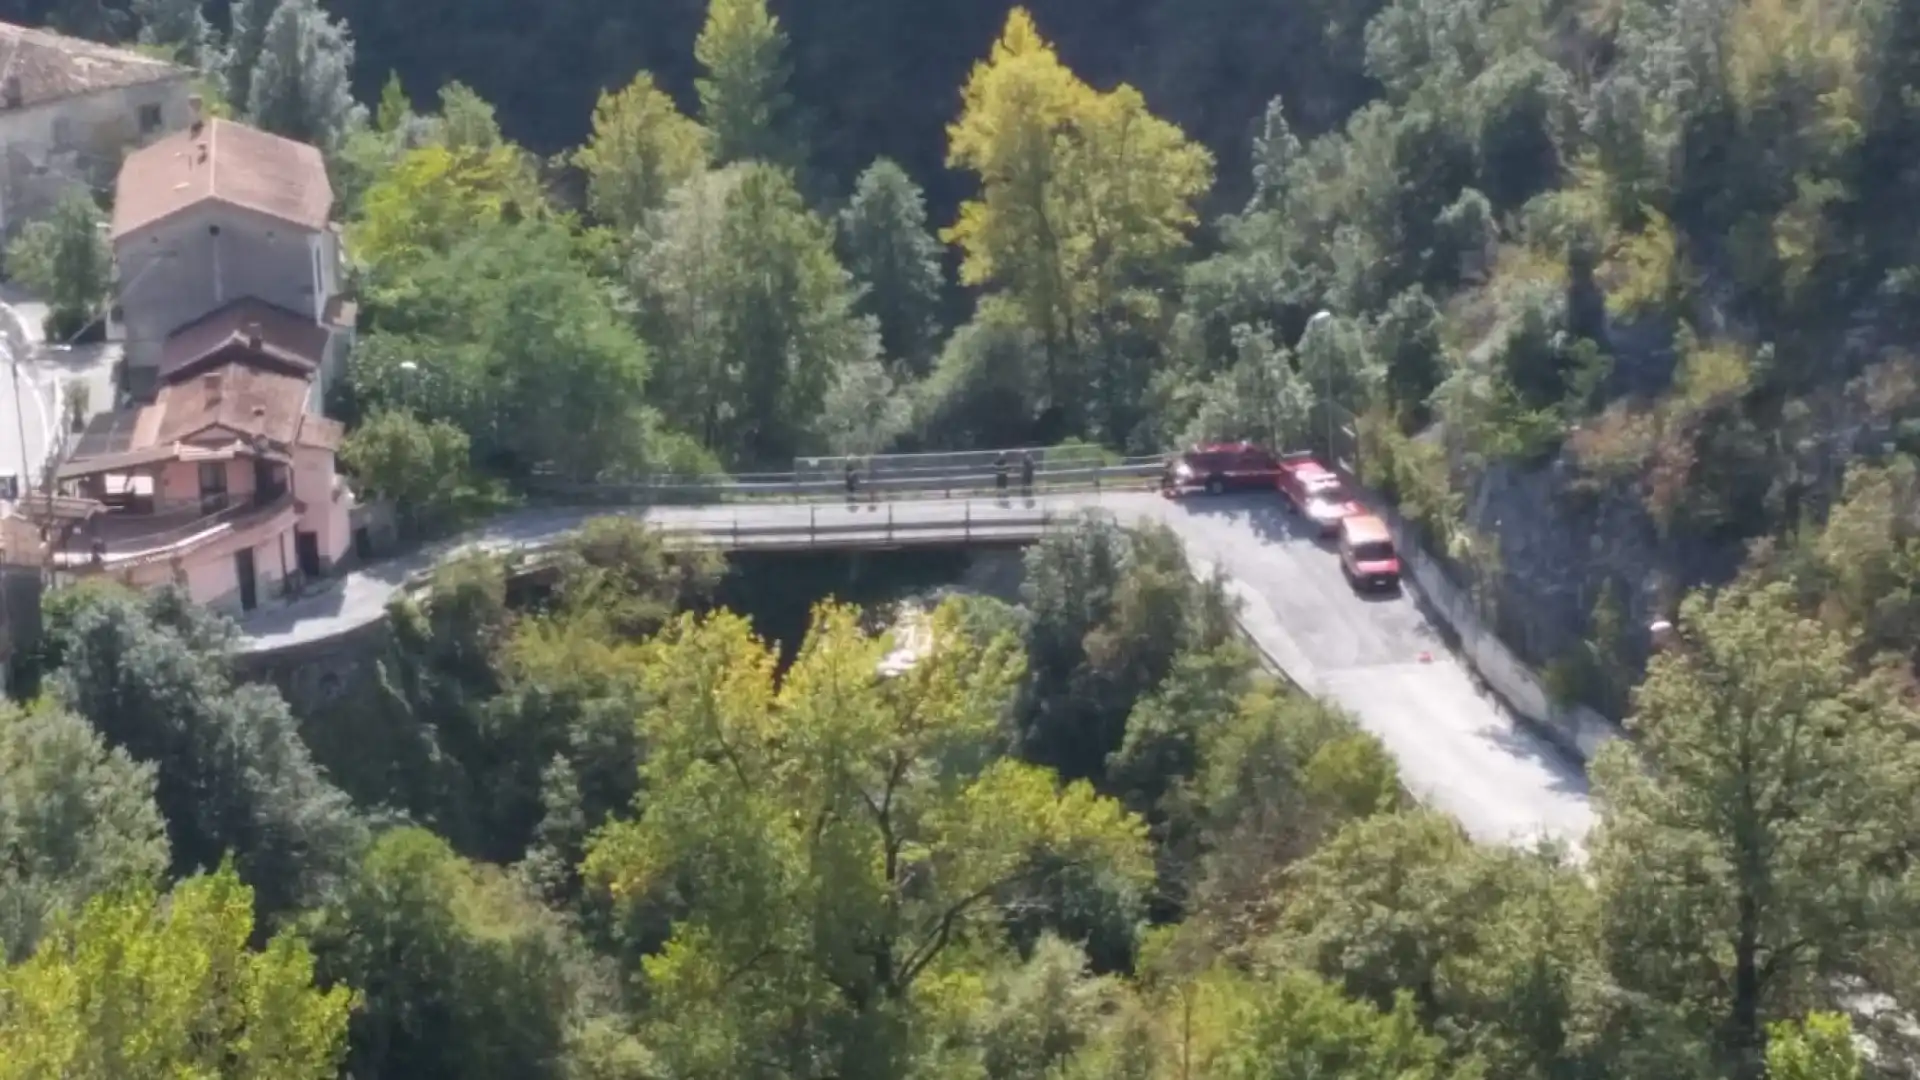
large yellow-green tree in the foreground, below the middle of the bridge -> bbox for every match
[586,605,1152,1078]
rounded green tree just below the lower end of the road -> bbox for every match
[1273,811,1612,1076]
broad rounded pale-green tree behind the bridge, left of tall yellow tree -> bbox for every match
[630,163,877,465]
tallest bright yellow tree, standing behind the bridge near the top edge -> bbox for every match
[943,8,1213,430]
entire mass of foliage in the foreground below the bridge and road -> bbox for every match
[0,507,1896,1080]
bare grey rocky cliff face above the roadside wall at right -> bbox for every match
[1450,309,1920,707]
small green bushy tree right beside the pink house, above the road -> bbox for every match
[340,409,472,534]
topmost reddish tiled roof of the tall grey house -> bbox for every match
[113,119,334,240]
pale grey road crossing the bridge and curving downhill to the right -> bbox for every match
[242,492,1594,846]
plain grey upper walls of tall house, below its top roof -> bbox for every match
[113,202,340,386]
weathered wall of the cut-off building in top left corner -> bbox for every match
[0,73,192,238]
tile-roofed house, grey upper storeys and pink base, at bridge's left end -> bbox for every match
[19,115,353,613]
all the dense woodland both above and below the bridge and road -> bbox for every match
[11,0,1920,1080]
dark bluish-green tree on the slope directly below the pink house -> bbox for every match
[54,590,365,915]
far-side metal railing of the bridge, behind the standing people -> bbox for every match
[532,455,1164,505]
